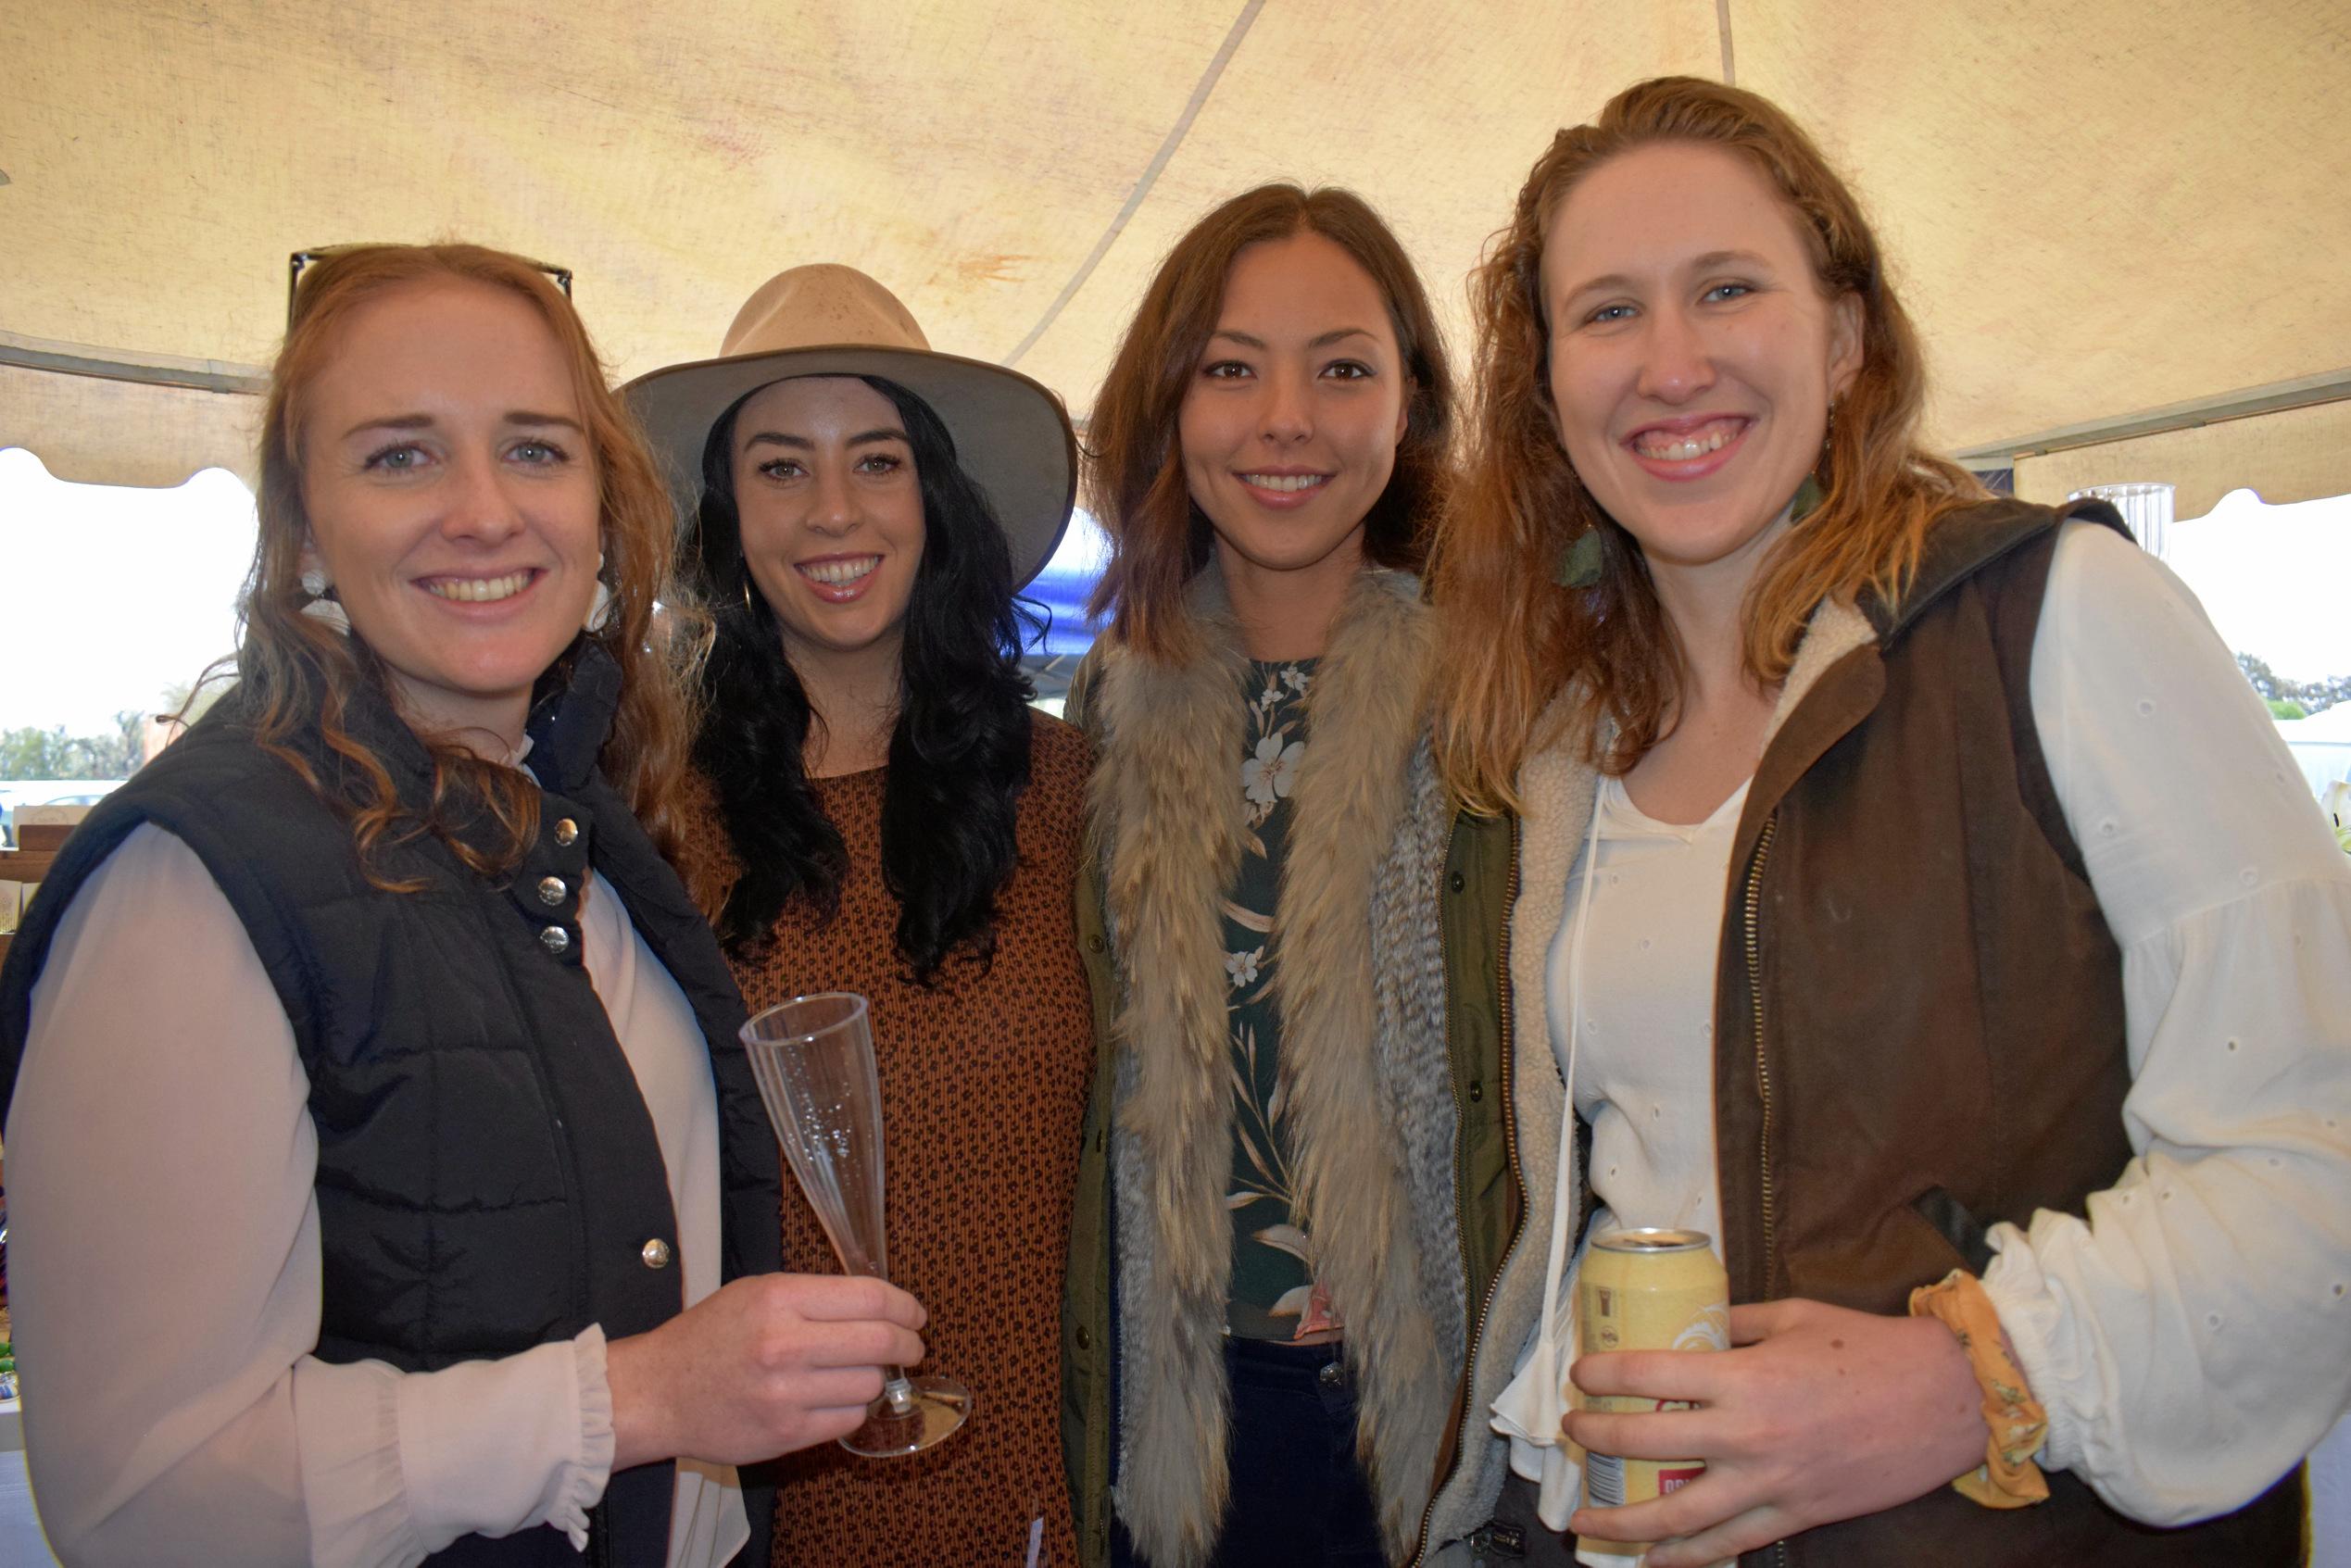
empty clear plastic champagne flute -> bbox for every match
[743,992,971,1458]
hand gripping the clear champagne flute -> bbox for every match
[604,1274,924,1469]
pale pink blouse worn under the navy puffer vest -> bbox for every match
[7,825,750,1568]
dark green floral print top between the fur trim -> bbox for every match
[1223,659,1340,1340]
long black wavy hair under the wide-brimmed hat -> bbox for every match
[686,376,1041,985]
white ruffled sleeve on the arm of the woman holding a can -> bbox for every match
[1984,524,2351,1525]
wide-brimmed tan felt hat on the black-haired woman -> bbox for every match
[621,263,1076,588]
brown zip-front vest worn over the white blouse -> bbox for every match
[1714,501,2308,1568]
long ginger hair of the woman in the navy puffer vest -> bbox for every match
[235,245,708,891]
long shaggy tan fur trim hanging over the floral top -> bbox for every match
[1093,569,1458,1568]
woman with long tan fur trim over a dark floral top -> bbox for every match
[1070,186,1465,1568]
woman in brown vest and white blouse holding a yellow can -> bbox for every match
[1434,78,2351,1568]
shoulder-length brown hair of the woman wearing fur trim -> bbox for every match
[1084,183,1452,663]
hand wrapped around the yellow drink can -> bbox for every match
[1565,1300,1987,1568]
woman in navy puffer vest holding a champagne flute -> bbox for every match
[0,245,922,1568]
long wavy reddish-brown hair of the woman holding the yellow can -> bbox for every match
[1432,75,1984,811]
